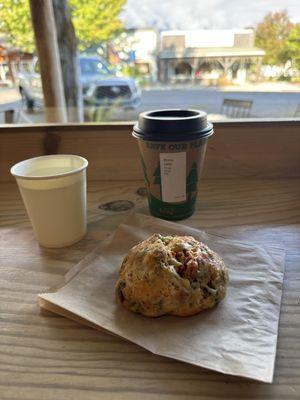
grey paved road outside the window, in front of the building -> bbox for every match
[0,88,300,123]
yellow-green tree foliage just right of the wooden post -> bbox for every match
[68,0,126,50]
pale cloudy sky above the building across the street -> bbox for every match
[122,0,300,30]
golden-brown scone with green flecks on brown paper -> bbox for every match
[116,233,228,317]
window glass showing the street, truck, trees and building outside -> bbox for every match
[0,0,300,123]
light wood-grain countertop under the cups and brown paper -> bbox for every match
[0,179,300,400]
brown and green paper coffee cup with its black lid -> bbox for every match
[133,110,213,220]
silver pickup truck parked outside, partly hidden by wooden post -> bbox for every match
[17,56,141,109]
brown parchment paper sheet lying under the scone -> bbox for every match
[39,214,284,382]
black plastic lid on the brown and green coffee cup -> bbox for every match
[132,109,213,141]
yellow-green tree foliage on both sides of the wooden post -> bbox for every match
[0,0,126,52]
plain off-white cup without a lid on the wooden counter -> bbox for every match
[10,154,88,247]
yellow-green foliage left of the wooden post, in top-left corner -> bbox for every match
[0,0,34,53]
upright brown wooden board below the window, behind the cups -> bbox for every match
[0,120,300,181]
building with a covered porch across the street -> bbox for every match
[157,29,265,85]
